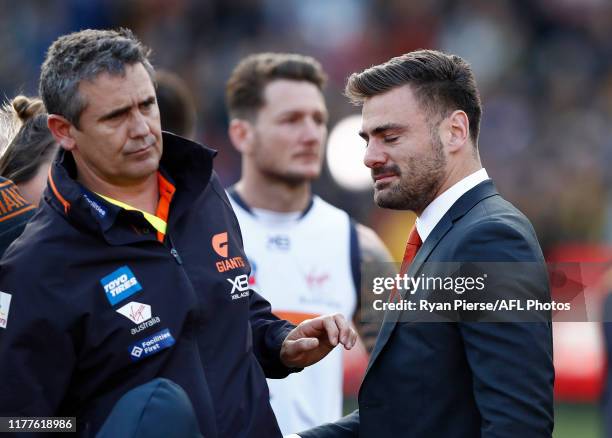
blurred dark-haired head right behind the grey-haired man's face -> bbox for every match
[155,70,196,137]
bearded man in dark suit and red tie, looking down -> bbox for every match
[300,50,554,438]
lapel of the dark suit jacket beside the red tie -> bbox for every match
[366,180,498,375]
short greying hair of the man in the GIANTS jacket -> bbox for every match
[39,28,154,128]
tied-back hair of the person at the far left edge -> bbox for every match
[0,96,58,184]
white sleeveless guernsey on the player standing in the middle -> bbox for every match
[229,189,359,434]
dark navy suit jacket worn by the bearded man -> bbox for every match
[300,180,554,438]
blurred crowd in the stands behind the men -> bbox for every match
[0,0,612,436]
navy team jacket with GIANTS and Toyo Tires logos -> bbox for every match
[0,133,293,438]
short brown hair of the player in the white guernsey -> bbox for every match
[225,53,327,118]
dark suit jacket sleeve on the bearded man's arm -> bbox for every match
[459,222,554,438]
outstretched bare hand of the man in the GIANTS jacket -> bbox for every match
[280,313,357,368]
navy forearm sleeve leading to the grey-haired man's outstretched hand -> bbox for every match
[249,290,302,379]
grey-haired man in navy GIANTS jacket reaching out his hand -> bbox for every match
[0,30,356,438]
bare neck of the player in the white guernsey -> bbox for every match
[235,176,311,213]
